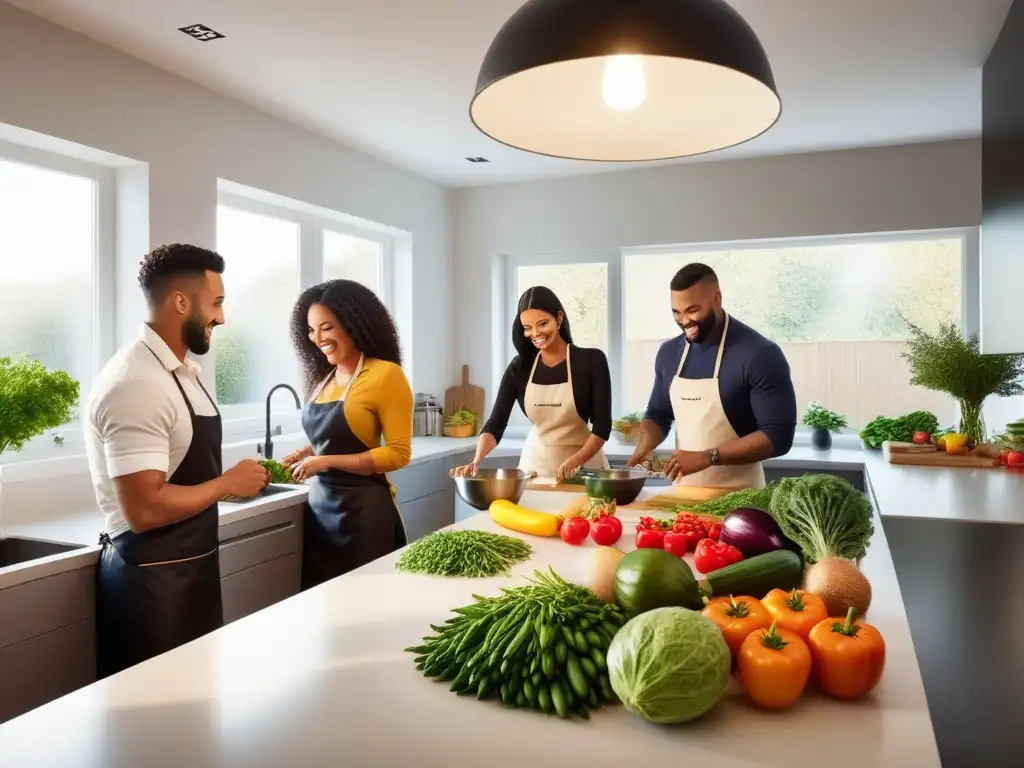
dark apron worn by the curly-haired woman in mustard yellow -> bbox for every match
[302,366,406,590]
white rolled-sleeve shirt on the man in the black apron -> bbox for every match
[85,325,217,537]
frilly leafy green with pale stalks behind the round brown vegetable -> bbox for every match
[766,474,874,563]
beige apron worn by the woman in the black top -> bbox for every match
[519,345,608,477]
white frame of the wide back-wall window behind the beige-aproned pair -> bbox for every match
[492,226,981,446]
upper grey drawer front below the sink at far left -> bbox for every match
[0,565,96,651]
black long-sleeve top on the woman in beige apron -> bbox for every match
[481,344,611,442]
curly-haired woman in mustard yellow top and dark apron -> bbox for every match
[282,280,413,589]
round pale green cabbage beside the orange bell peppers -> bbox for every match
[607,607,731,724]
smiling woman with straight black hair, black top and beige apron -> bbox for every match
[455,286,611,482]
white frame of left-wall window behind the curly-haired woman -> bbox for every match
[212,189,395,421]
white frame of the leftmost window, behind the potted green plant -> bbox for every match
[0,140,117,464]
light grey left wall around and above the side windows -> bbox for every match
[0,2,452,399]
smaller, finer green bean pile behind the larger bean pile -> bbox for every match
[395,530,534,579]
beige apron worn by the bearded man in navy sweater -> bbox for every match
[669,314,765,488]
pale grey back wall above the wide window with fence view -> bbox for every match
[452,139,1024,434]
